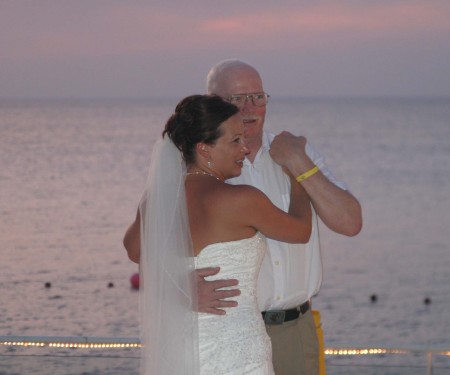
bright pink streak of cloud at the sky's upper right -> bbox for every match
[202,2,450,43]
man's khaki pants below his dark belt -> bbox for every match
[266,310,321,375]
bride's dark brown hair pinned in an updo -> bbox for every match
[163,95,239,165]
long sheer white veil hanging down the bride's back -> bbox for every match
[139,136,199,375]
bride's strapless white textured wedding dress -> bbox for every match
[195,233,274,375]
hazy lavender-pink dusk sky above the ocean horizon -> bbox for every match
[0,0,450,98]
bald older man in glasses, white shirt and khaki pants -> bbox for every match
[198,60,362,375]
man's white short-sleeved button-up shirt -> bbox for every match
[228,132,347,311]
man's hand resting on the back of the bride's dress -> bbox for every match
[195,267,241,315]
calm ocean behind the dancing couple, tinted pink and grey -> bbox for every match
[0,98,450,374]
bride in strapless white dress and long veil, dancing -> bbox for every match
[124,95,311,375]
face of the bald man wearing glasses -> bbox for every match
[216,67,266,156]
